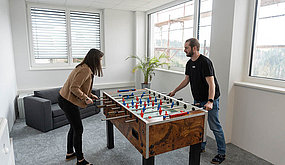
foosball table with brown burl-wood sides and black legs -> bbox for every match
[98,88,208,165]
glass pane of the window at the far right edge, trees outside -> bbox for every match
[249,0,285,80]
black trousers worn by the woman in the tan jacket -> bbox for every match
[58,95,83,160]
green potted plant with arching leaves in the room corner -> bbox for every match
[126,53,170,88]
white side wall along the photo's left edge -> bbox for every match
[0,0,17,130]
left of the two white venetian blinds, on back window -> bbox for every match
[31,7,68,59]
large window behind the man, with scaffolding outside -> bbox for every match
[148,0,212,71]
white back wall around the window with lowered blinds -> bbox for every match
[10,0,135,91]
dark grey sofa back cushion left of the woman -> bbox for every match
[34,88,60,104]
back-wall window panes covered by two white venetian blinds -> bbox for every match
[29,6,101,67]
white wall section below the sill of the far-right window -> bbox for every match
[232,85,285,165]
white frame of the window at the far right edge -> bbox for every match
[243,0,285,88]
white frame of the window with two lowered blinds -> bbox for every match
[26,2,105,70]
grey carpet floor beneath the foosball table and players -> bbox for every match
[10,113,271,165]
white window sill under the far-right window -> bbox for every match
[234,82,285,94]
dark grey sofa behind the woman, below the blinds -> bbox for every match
[24,88,100,132]
